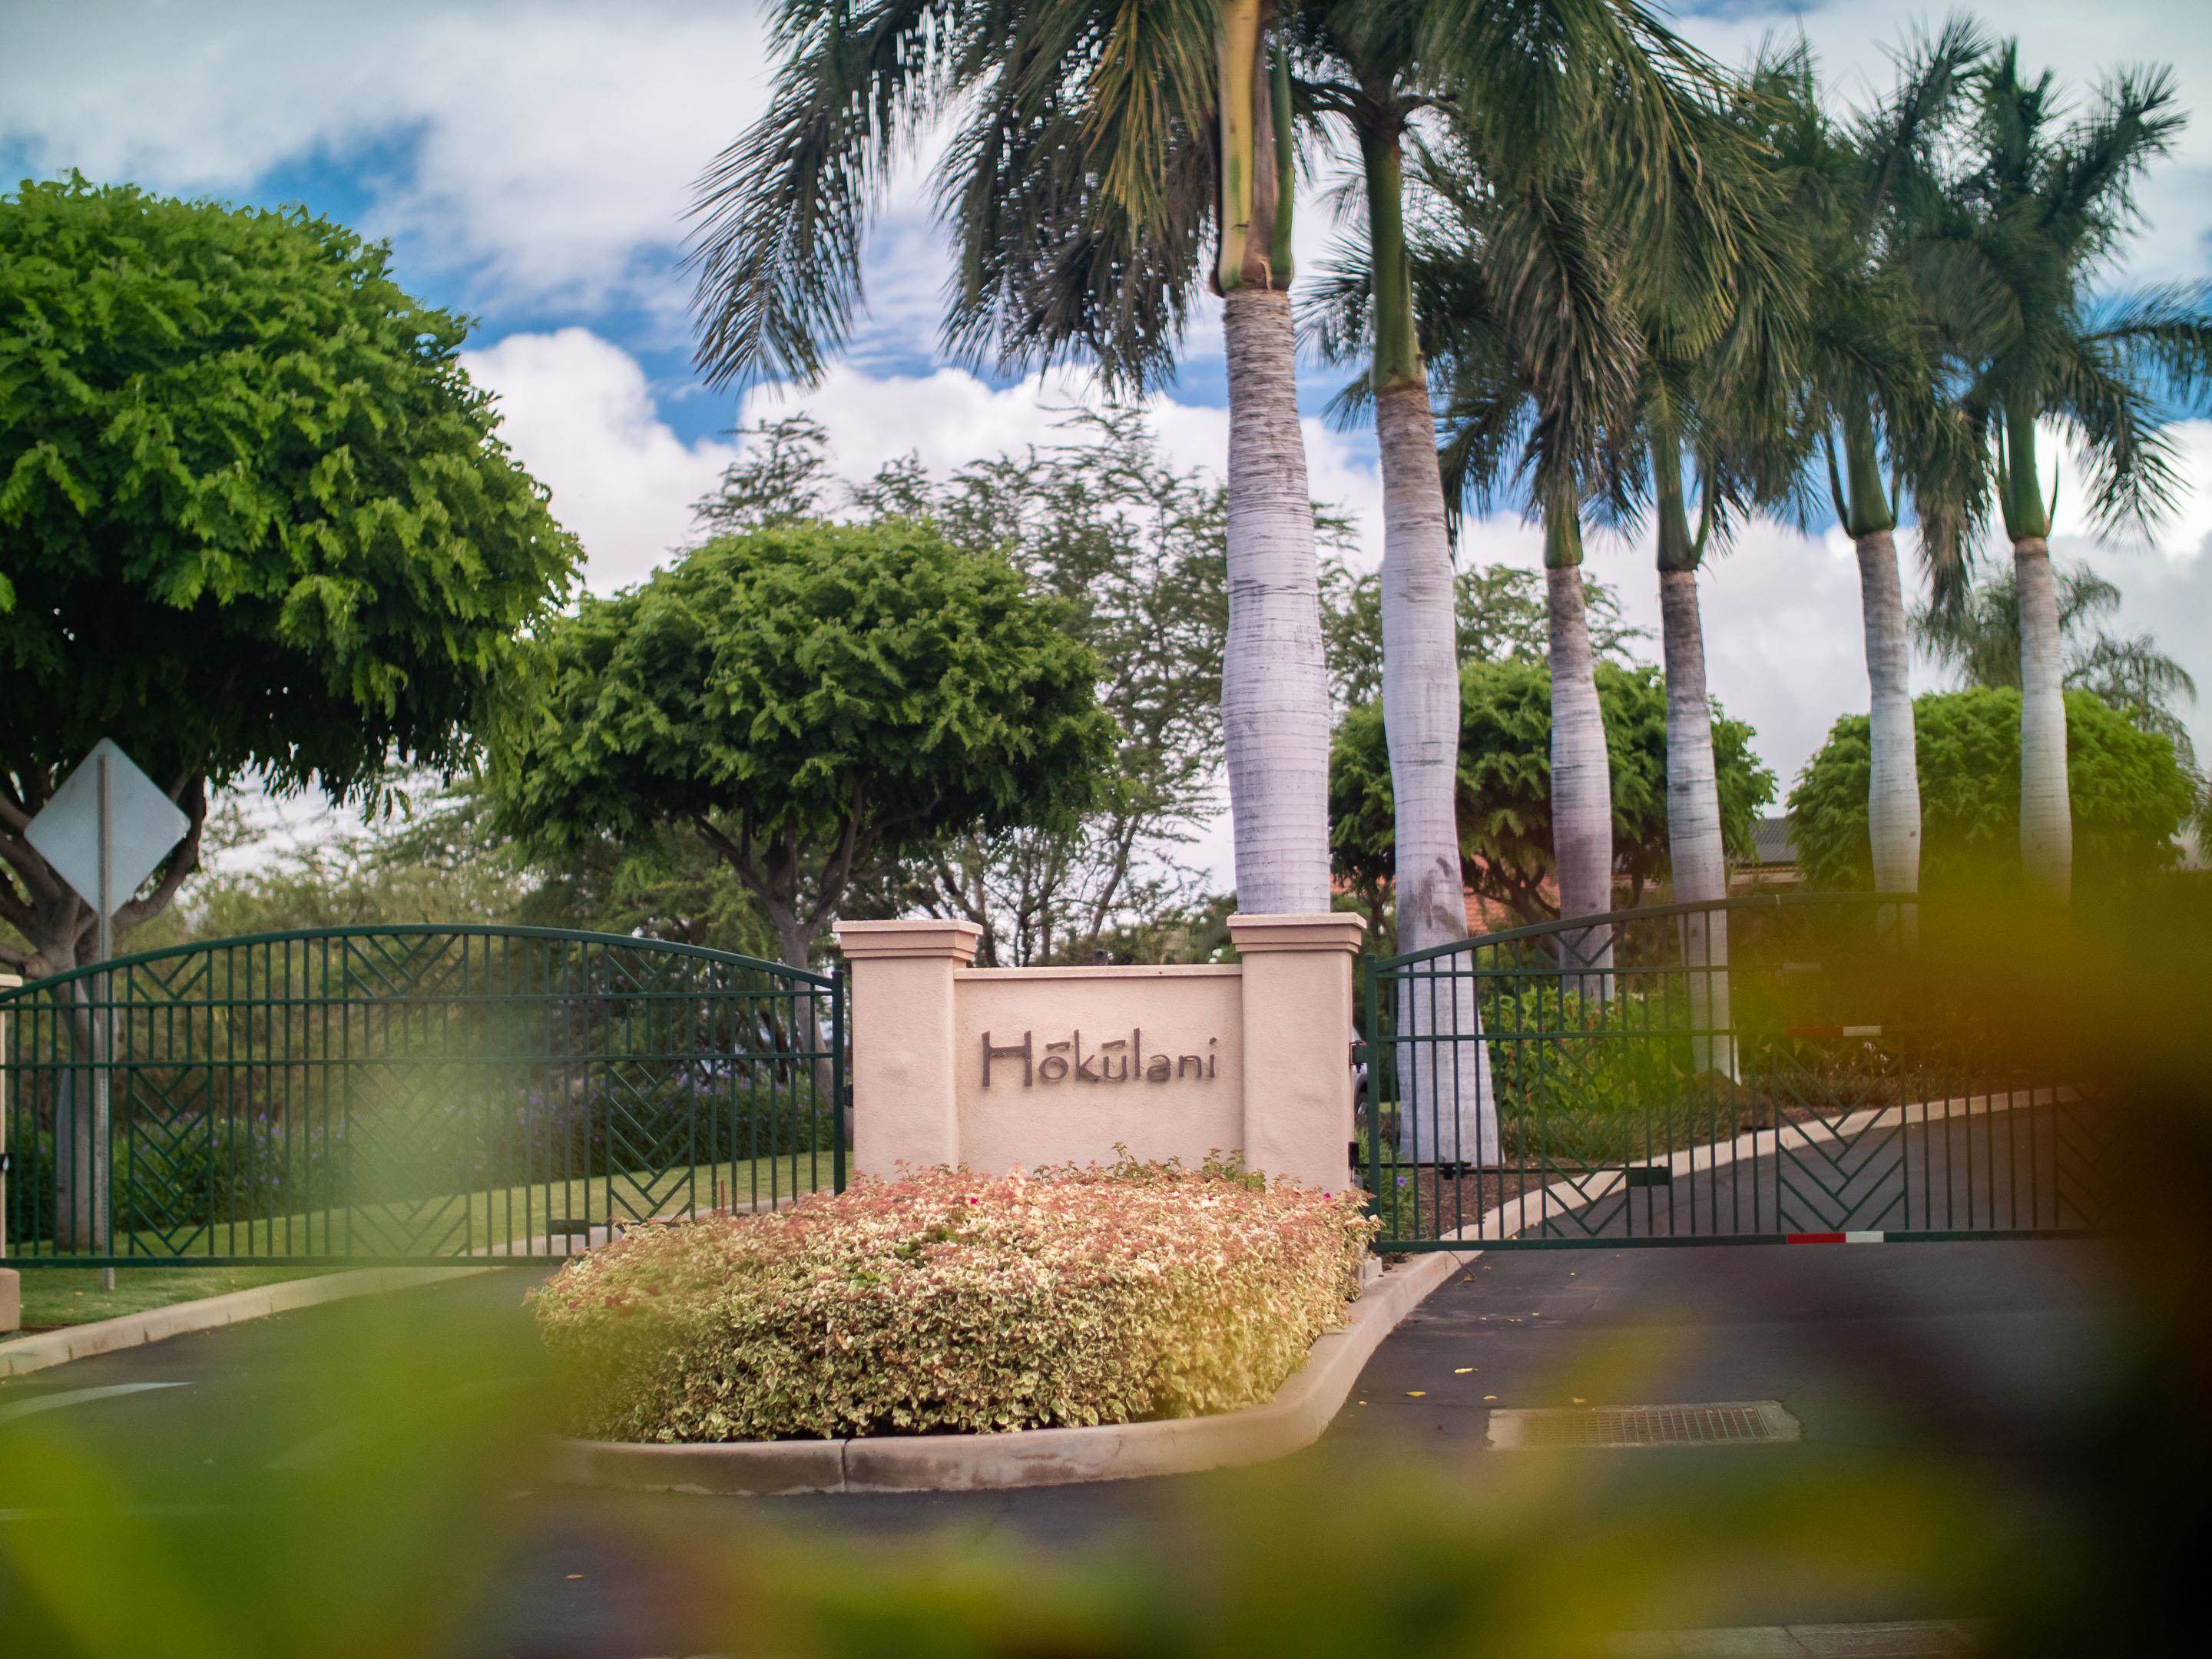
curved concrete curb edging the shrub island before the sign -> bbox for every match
[539,1252,1480,1495]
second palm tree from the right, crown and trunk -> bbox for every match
[1745,20,1986,894]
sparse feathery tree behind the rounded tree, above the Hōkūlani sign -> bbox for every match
[681,409,1238,967]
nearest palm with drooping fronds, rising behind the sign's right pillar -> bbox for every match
[692,0,1330,912]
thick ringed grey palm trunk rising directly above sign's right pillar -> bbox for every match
[1221,287,1330,913]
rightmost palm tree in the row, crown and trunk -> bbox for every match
[1909,45,2212,900]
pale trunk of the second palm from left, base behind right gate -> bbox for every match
[1376,380,1498,1164]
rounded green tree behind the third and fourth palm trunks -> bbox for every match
[1330,661,1774,946]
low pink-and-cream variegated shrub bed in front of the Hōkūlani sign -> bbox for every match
[531,1161,1373,1440]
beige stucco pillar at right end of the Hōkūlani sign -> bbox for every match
[1230,912,1367,1192]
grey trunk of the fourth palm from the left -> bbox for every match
[1659,566,1737,1078]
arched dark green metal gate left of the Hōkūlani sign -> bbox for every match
[0,927,847,1267]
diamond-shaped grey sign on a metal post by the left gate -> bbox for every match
[25,737,193,1290]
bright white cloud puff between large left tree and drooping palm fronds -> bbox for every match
[462,327,737,593]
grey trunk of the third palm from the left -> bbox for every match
[1544,508,1613,998]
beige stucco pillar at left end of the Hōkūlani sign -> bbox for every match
[836,920,982,1179]
